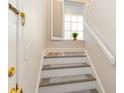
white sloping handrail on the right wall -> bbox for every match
[84,21,116,65]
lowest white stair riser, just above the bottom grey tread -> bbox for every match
[39,81,96,93]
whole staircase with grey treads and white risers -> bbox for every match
[39,52,98,93]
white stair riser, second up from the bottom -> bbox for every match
[41,67,93,78]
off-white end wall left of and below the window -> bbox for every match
[46,0,85,48]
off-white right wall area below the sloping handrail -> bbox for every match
[85,28,116,93]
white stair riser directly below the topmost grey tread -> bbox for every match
[43,57,88,65]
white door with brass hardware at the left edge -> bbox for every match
[8,0,18,91]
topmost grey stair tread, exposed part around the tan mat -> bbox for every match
[44,52,86,58]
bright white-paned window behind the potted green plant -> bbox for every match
[64,15,83,40]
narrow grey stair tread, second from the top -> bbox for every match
[43,63,90,70]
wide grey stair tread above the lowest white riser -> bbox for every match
[39,74,96,87]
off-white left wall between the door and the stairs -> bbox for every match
[19,0,47,93]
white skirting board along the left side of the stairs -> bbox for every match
[35,49,46,93]
